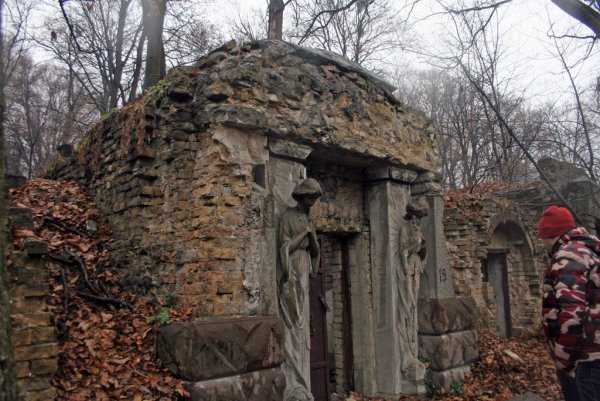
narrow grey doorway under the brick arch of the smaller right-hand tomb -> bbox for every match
[484,248,512,337]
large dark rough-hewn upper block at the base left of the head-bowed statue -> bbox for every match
[157,316,283,381]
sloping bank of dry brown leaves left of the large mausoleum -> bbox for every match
[11,179,192,401]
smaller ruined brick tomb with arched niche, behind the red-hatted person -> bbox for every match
[444,158,600,337]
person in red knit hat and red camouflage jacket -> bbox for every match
[538,206,600,401]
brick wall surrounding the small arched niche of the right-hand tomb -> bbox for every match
[444,196,545,334]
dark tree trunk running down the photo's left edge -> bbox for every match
[0,0,17,401]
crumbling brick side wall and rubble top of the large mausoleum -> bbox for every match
[52,41,437,316]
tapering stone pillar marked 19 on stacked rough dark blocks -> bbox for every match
[412,172,479,387]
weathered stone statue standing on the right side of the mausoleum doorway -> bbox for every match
[397,202,428,380]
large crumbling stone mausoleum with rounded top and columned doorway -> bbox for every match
[53,41,478,401]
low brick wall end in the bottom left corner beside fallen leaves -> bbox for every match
[8,207,58,401]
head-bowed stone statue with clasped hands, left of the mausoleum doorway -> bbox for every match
[277,178,322,401]
